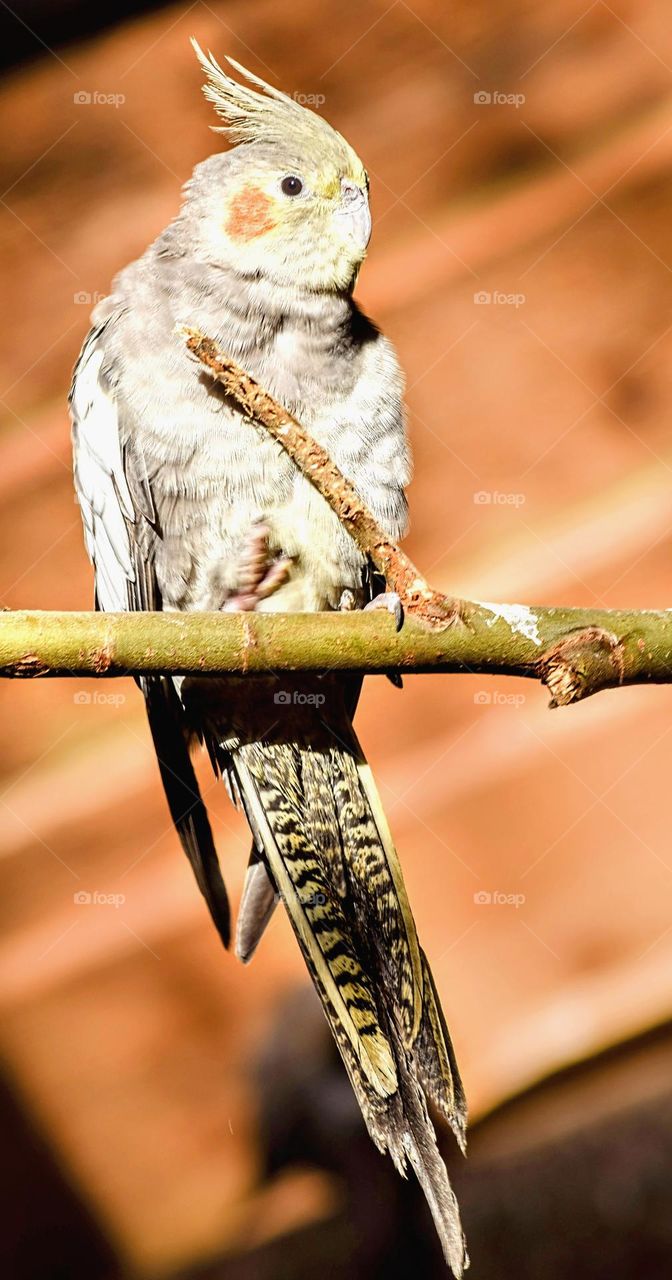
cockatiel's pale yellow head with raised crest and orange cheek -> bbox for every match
[188,41,371,293]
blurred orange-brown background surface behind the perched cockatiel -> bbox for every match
[0,0,672,1280]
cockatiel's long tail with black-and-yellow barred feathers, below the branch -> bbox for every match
[227,728,468,1277]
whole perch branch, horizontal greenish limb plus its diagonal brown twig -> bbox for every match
[0,329,672,707]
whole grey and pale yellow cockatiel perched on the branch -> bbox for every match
[70,46,467,1276]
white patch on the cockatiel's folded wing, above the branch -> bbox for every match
[70,334,136,612]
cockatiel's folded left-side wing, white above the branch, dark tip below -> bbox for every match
[70,321,230,946]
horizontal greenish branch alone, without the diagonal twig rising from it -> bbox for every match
[0,602,672,707]
